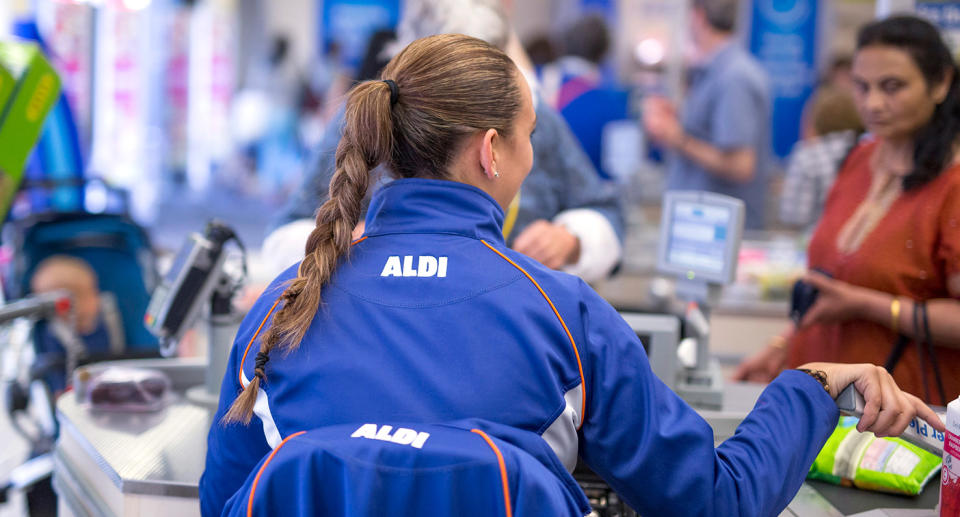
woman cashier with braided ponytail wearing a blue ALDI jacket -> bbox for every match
[200,34,942,516]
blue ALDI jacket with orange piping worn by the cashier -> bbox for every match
[200,179,838,517]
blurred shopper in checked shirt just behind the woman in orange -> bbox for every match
[780,58,864,229]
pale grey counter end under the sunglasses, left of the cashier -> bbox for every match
[53,359,206,517]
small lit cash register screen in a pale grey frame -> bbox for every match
[658,192,743,284]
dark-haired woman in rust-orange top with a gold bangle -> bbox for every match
[735,16,960,405]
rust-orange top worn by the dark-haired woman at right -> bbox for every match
[789,142,960,405]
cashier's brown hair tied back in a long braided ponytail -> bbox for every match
[223,34,521,424]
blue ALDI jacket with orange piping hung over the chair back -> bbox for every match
[224,421,590,517]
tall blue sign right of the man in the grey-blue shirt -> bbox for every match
[750,0,818,158]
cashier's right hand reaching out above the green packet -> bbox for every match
[800,363,946,437]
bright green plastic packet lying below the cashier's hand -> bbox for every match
[807,416,943,495]
